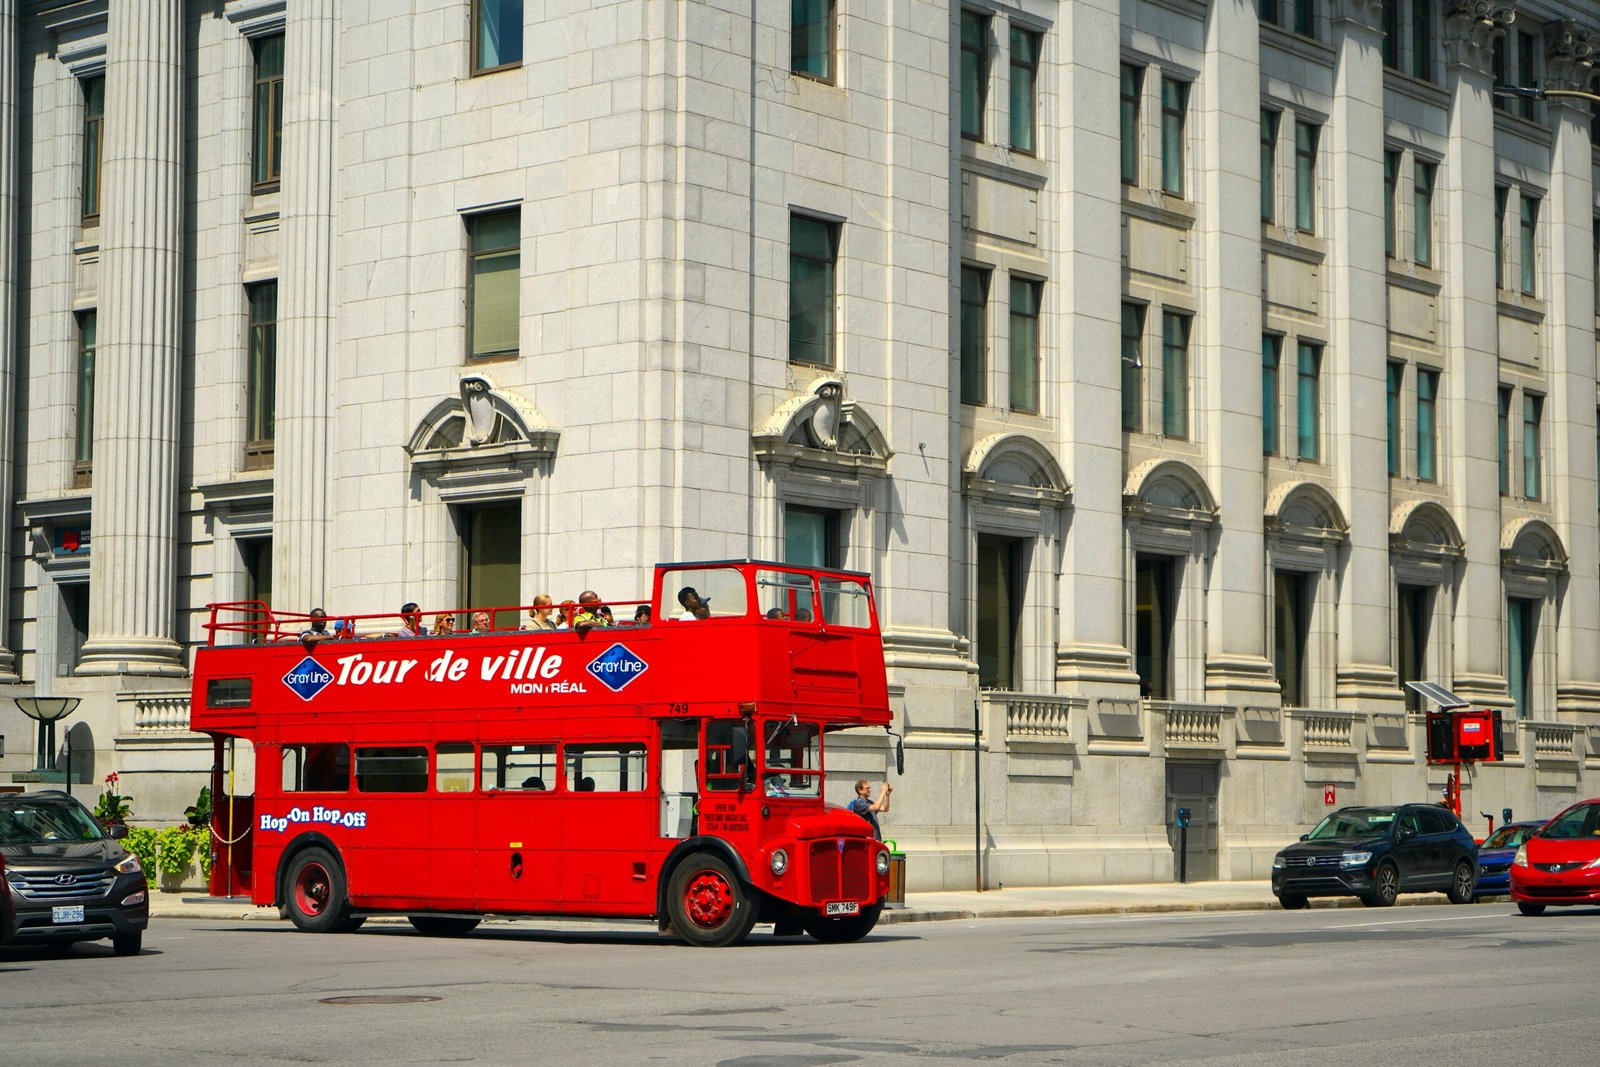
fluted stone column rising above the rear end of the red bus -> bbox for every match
[272,0,339,611]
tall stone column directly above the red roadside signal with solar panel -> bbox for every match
[1438,0,1515,704]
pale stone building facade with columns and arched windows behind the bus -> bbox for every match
[9,0,1600,888]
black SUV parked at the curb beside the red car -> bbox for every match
[1272,805,1478,909]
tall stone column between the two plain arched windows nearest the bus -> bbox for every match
[1050,0,1139,697]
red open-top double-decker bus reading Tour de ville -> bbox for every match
[190,561,890,945]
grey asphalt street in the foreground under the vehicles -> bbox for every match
[0,901,1600,1067]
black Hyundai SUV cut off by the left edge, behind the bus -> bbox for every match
[0,792,150,957]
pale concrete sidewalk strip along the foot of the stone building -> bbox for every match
[150,881,1292,925]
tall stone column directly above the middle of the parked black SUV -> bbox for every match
[1325,0,1400,709]
